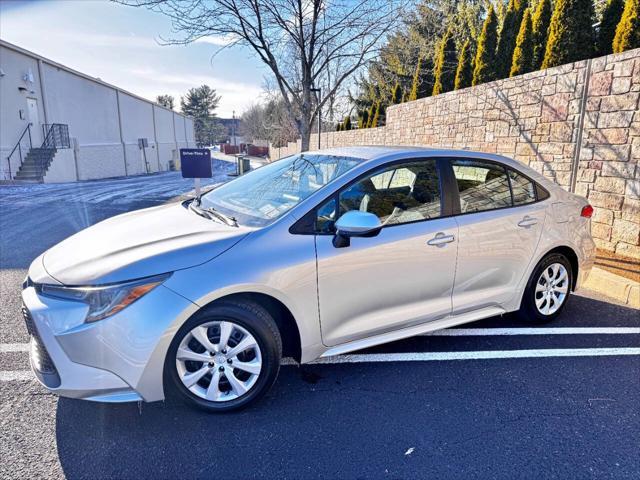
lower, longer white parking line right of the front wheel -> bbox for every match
[298,348,640,365]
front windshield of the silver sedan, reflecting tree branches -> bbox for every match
[200,153,362,227]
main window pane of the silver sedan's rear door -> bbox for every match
[451,159,512,213]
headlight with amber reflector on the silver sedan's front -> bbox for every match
[38,274,171,322]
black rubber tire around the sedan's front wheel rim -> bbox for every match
[164,300,282,413]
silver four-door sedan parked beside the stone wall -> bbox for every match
[22,147,595,412]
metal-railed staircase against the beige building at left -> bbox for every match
[7,123,71,183]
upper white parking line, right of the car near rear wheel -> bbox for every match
[422,327,640,337]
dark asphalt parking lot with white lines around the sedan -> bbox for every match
[0,165,640,479]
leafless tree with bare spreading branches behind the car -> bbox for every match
[114,0,406,150]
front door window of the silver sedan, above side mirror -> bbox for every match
[328,159,441,225]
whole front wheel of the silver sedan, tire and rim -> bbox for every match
[165,301,282,412]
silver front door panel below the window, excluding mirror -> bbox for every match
[316,218,458,346]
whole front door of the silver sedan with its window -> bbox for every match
[316,159,458,346]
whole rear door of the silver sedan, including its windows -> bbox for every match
[450,159,545,314]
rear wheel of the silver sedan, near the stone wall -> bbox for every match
[519,253,573,323]
